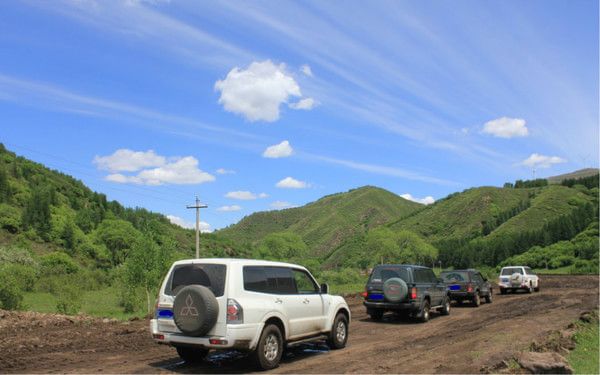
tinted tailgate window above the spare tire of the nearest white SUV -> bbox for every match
[165,264,227,297]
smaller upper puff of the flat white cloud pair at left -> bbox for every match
[94,148,166,172]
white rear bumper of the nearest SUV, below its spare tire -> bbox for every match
[150,319,263,350]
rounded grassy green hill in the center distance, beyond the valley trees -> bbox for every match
[218,186,423,257]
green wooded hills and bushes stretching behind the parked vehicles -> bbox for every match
[0,144,599,318]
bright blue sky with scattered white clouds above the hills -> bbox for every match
[0,0,599,229]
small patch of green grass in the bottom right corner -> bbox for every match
[568,321,600,374]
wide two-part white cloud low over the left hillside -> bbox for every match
[99,150,215,185]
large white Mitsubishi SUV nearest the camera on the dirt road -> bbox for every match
[150,259,350,369]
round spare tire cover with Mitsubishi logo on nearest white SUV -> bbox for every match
[173,285,219,336]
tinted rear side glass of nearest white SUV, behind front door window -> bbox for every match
[243,266,298,294]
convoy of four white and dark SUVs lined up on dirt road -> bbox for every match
[150,259,540,370]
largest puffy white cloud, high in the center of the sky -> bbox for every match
[215,60,314,122]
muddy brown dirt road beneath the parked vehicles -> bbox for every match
[0,276,598,373]
